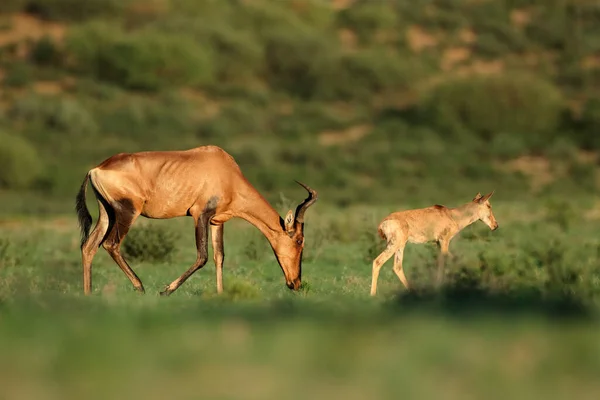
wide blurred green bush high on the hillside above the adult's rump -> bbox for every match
[67,22,214,90]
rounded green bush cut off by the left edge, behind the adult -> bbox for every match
[0,131,43,189]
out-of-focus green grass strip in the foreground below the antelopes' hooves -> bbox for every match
[0,294,600,399]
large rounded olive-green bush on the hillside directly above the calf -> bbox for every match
[421,73,564,145]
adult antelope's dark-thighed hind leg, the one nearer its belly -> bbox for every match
[102,202,145,293]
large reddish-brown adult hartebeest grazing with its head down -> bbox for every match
[76,146,317,295]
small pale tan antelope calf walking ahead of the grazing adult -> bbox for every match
[371,191,498,296]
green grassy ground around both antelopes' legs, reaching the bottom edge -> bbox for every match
[0,200,600,399]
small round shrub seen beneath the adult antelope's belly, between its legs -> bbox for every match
[123,225,178,262]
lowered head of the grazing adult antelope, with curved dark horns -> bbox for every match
[275,181,317,290]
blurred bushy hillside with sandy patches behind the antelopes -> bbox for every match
[0,0,600,213]
